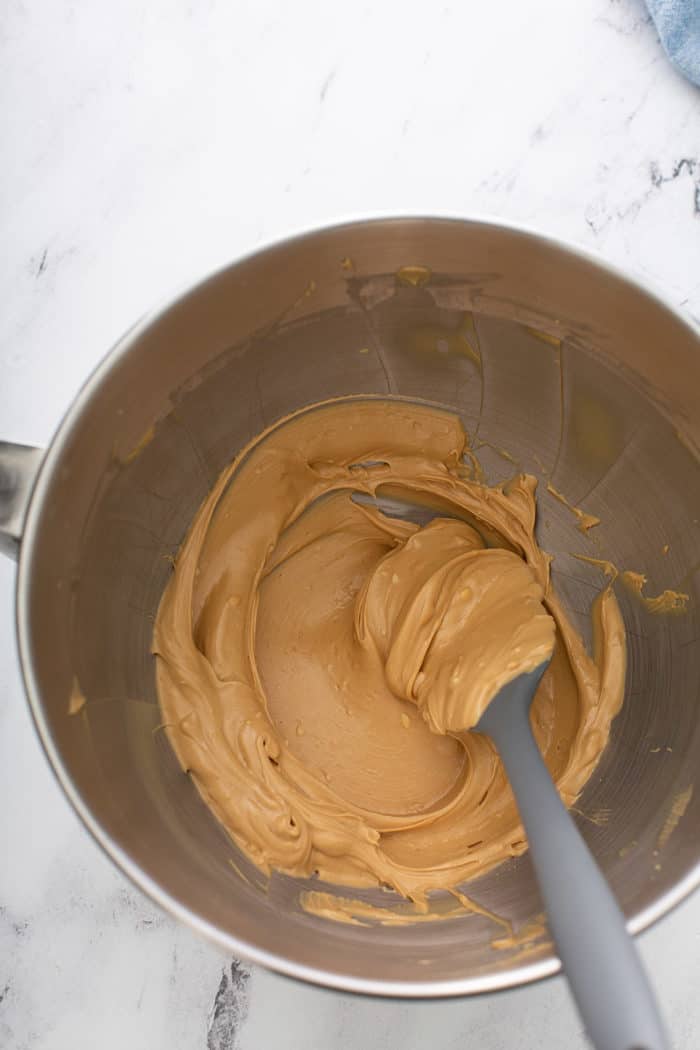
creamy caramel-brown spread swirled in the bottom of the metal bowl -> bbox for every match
[153,398,625,903]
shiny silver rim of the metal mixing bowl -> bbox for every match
[16,211,700,1000]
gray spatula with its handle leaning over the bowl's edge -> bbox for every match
[353,492,669,1050]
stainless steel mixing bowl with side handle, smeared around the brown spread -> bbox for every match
[0,218,700,996]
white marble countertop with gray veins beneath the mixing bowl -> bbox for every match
[0,0,700,1050]
